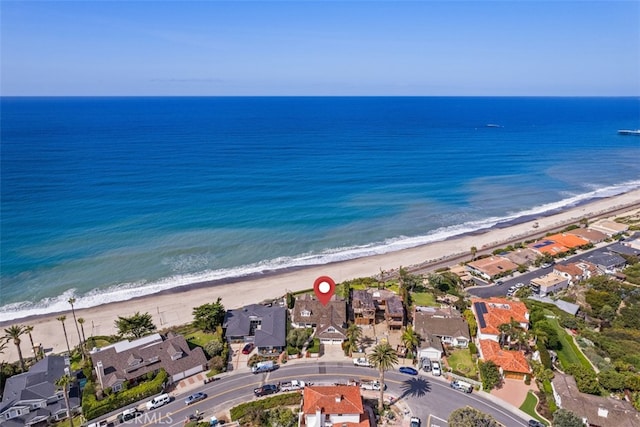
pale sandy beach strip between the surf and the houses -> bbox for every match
[1,190,640,361]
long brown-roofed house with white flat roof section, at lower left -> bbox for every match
[90,332,207,392]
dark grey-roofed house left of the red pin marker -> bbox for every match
[222,304,287,354]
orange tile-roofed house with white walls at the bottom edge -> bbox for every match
[298,385,371,427]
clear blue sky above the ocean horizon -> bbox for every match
[0,0,640,96]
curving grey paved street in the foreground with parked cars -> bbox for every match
[131,362,528,426]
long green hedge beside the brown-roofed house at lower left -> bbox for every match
[82,369,168,420]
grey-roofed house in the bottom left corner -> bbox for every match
[0,356,80,427]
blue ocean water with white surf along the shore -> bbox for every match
[0,97,640,321]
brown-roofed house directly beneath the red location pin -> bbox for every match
[291,294,347,344]
